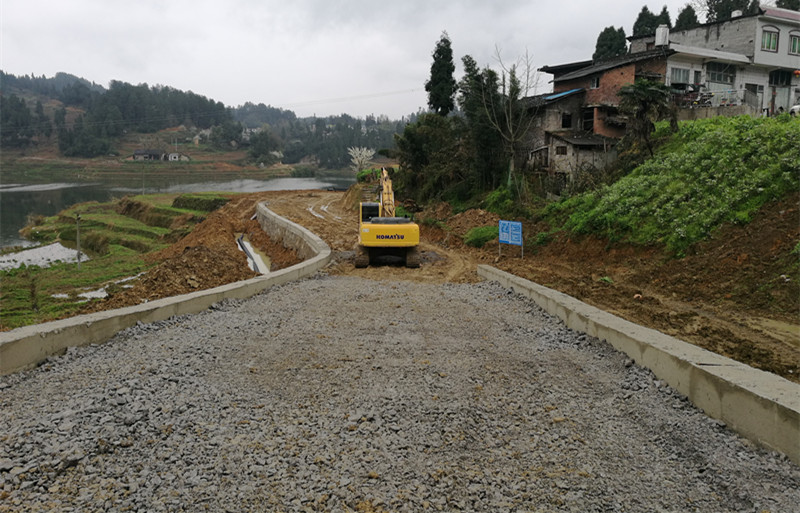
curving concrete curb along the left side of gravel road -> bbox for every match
[0,203,331,375]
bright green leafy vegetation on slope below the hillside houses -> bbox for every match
[543,116,800,255]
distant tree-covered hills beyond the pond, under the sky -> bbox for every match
[0,70,405,169]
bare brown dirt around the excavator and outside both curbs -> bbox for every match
[84,191,800,382]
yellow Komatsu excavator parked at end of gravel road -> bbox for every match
[355,168,420,267]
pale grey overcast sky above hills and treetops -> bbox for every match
[0,0,702,119]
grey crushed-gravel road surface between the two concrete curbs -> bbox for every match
[0,274,800,512]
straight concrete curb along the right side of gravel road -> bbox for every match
[478,265,800,464]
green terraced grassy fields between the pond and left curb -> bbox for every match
[0,193,225,329]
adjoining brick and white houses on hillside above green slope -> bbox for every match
[525,6,800,188]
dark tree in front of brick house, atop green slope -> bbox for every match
[619,79,674,157]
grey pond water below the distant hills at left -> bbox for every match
[0,175,355,248]
